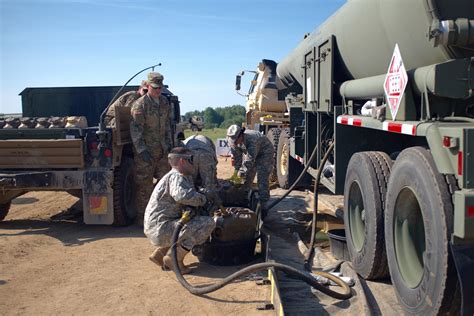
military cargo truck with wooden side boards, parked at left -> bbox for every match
[0,87,180,225]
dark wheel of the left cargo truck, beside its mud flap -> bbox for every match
[114,156,137,226]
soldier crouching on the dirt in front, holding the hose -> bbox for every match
[144,147,216,274]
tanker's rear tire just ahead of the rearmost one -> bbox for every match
[344,152,392,279]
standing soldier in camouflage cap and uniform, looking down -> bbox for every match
[130,72,173,225]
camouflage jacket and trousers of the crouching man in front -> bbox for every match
[143,169,216,250]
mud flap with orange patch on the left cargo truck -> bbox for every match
[82,170,114,225]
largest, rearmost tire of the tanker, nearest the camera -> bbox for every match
[385,147,457,315]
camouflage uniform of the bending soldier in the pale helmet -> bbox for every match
[233,130,274,202]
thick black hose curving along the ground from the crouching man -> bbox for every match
[171,220,352,300]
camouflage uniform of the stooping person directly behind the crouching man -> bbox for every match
[183,135,217,189]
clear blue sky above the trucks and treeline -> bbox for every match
[0,0,345,113]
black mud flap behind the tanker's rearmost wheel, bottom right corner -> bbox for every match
[450,243,474,316]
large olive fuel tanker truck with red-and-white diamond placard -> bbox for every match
[236,0,474,315]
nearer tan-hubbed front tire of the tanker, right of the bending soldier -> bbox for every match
[276,128,312,189]
